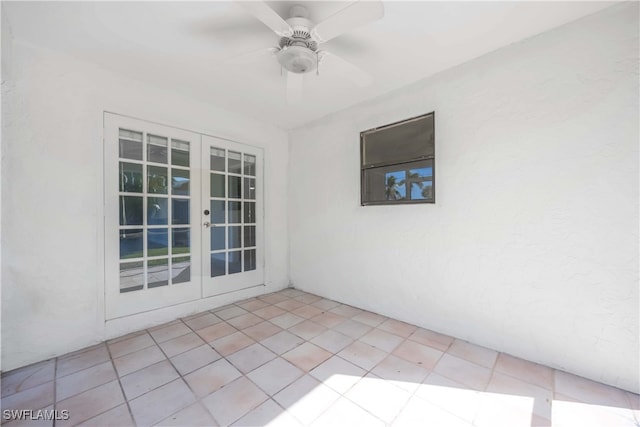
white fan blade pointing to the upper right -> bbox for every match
[311,0,384,43]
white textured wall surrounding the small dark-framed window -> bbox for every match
[289,2,640,392]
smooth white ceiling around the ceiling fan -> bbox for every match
[2,1,614,129]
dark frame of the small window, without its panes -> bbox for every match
[360,111,436,206]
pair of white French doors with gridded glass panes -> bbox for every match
[104,113,263,319]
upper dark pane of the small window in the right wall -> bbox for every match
[362,114,434,165]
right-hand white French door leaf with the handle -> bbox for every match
[201,135,264,297]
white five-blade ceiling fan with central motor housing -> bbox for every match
[226,0,384,104]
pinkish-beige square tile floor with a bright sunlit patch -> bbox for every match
[2,289,640,427]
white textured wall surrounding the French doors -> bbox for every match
[1,39,288,370]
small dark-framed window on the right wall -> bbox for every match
[360,113,435,206]
